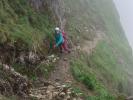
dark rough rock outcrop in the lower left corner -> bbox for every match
[0,64,31,97]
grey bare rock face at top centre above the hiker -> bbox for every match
[29,0,66,29]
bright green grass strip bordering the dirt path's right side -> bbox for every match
[71,54,115,100]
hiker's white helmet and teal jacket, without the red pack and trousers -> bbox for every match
[54,27,64,52]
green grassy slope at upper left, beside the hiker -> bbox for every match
[0,0,54,48]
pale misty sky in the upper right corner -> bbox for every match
[114,0,133,48]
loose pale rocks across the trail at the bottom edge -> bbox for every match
[29,82,83,100]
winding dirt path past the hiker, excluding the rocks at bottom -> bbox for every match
[49,31,103,95]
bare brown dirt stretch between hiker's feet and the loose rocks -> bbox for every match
[49,55,73,83]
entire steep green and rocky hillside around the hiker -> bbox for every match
[0,0,133,100]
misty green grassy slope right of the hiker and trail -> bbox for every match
[66,0,133,100]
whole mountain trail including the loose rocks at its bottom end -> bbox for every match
[30,31,103,100]
